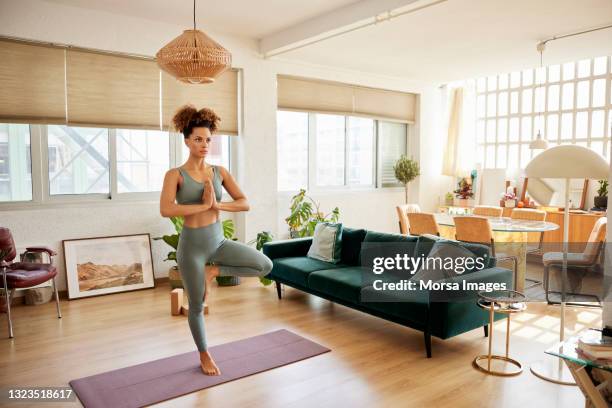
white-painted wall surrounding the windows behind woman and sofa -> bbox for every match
[0,0,447,289]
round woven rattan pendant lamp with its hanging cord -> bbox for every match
[155,0,232,84]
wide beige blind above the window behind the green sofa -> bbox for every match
[277,75,416,123]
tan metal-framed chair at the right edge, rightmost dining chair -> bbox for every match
[542,216,608,306]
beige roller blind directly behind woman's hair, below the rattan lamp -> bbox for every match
[162,70,238,135]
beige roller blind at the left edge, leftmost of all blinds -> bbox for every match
[0,40,65,123]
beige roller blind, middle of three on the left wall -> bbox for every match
[66,49,160,129]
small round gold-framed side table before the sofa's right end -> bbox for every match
[472,290,527,377]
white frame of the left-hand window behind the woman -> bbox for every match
[0,124,237,211]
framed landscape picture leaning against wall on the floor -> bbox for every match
[62,233,155,300]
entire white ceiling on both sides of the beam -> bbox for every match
[46,0,612,83]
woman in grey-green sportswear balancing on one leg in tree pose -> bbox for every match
[160,105,272,375]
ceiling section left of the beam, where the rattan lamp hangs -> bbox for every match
[45,0,358,39]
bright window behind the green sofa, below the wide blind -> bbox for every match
[277,111,408,191]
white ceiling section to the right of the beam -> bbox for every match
[282,0,612,82]
